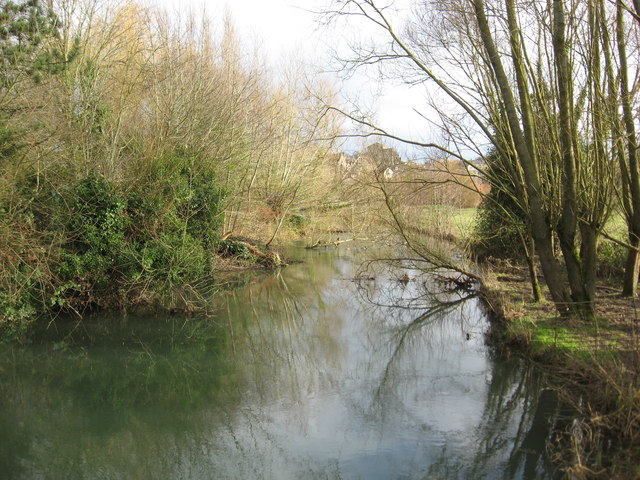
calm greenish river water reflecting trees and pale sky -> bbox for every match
[0,242,557,479]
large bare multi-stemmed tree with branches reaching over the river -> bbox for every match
[322,0,613,317]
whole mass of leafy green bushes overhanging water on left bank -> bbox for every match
[0,146,225,338]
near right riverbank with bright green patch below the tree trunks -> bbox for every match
[482,264,640,479]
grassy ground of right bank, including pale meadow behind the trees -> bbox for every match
[418,203,640,480]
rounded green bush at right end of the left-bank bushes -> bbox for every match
[127,153,226,285]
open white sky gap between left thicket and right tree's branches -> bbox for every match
[151,0,428,158]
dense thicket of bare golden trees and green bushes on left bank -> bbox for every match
[0,0,340,337]
